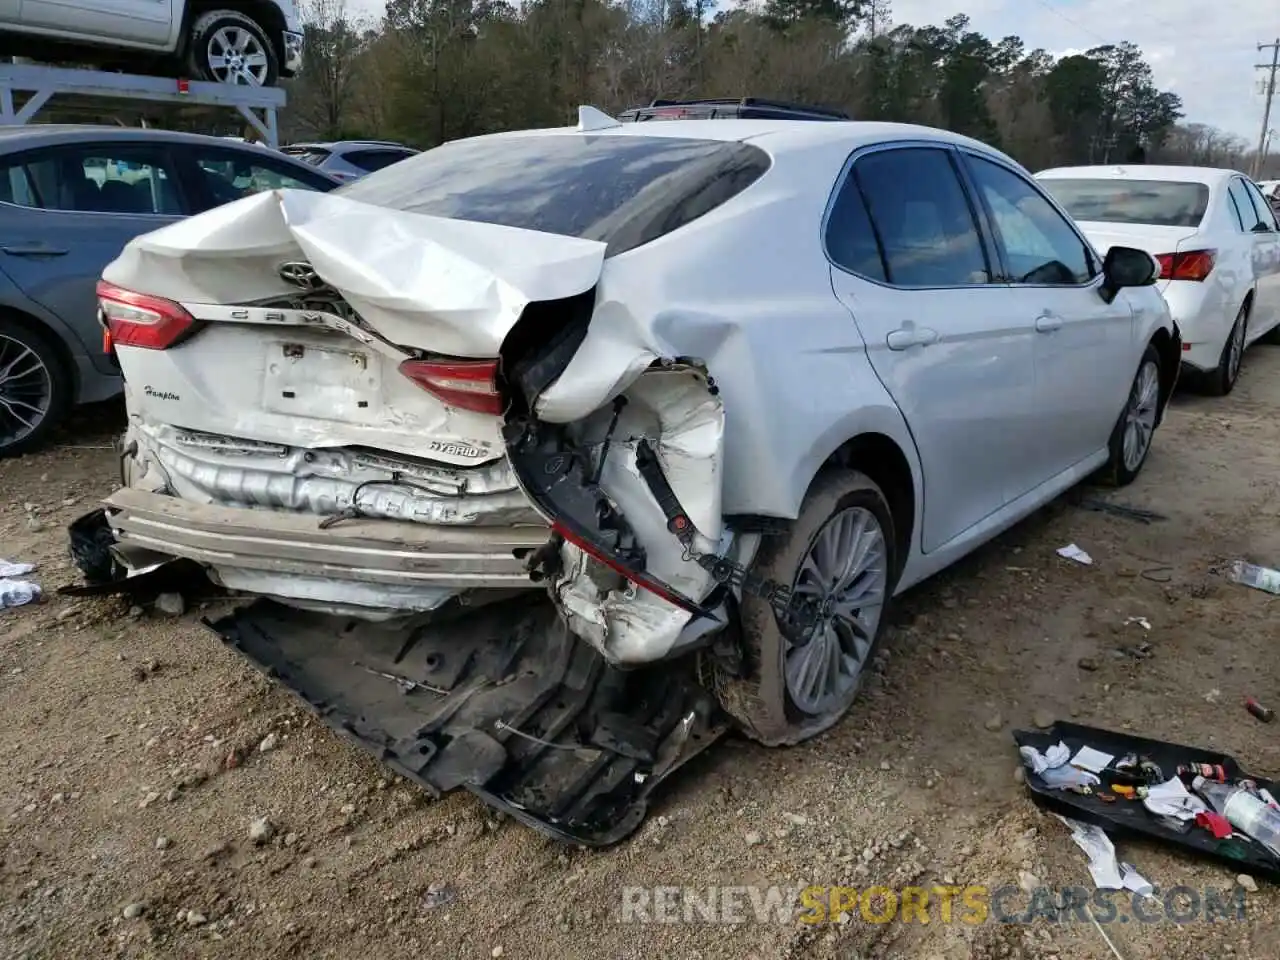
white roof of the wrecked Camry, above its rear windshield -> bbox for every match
[465,118,1002,156]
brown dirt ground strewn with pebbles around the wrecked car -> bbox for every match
[0,346,1280,960]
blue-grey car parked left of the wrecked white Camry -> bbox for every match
[0,124,338,457]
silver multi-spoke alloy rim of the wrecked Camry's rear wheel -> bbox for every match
[783,507,888,716]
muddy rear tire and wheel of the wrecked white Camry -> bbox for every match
[703,468,899,746]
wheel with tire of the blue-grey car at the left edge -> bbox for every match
[0,317,72,460]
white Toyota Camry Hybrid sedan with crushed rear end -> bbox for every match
[99,108,1181,749]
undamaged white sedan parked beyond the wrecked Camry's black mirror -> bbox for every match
[1037,165,1280,394]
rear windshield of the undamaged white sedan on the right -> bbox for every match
[1041,178,1208,227]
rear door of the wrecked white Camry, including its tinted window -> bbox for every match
[826,145,1036,552]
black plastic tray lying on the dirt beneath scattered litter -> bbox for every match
[1014,721,1280,883]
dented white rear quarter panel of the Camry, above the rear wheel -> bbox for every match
[536,134,920,527]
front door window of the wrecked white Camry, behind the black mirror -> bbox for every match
[968,155,1093,284]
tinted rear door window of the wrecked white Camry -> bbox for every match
[828,147,991,287]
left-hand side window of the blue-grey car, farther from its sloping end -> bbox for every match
[0,145,186,216]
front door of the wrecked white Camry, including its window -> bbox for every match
[964,151,1138,483]
